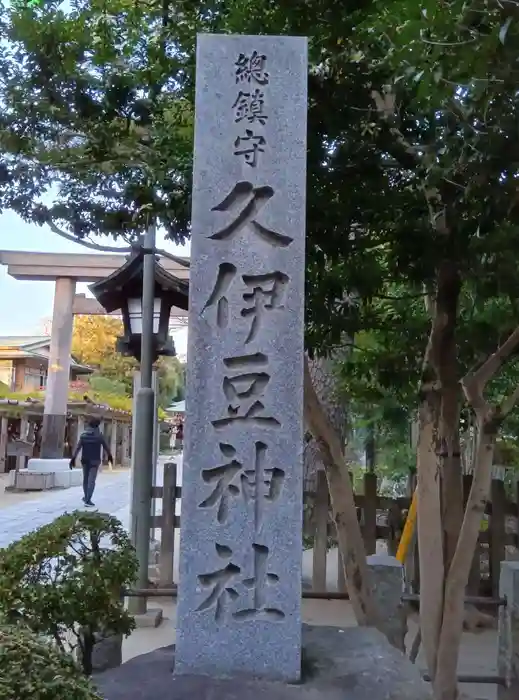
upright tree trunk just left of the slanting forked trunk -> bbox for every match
[417,260,463,681]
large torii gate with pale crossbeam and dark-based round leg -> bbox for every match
[0,250,189,459]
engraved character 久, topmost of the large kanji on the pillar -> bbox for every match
[209,181,293,248]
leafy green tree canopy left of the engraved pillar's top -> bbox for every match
[0,0,196,242]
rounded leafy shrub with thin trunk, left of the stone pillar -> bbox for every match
[0,511,137,675]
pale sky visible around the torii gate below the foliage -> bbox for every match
[0,212,189,357]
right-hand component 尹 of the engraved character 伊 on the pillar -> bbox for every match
[241,270,289,344]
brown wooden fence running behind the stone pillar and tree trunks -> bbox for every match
[148,463,519,597]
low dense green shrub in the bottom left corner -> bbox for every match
[0,626,101,700]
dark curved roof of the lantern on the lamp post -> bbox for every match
[89,248,189,313]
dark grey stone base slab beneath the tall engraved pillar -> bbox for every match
[94,625,432,700]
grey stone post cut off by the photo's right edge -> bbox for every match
[497,561,519,700]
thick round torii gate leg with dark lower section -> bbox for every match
[41,277,76,459]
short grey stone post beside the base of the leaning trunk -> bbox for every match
[367,554,407,652]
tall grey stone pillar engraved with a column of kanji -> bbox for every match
[175,34,308,681]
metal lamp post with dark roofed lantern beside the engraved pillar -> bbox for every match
[89,227,188,614]
